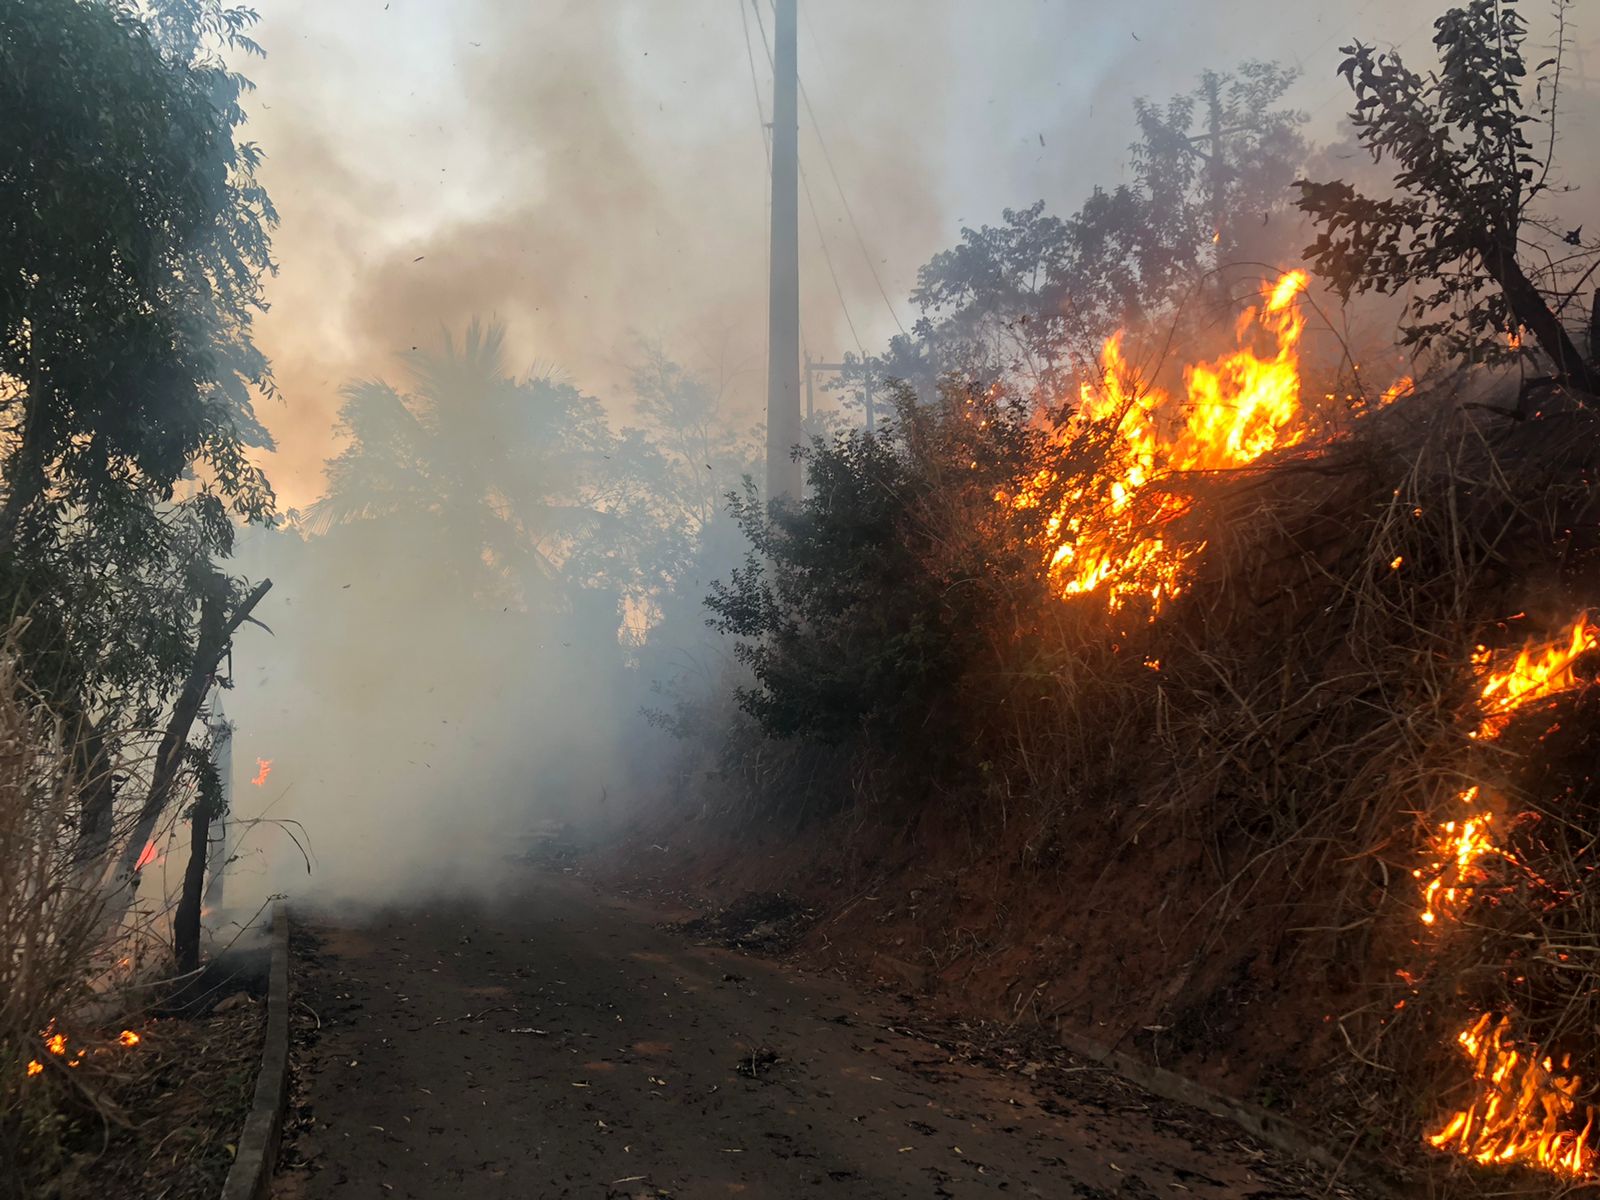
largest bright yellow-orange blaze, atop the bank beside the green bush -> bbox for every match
[1000,270,1309,611]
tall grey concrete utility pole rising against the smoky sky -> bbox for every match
[766,0,803,501]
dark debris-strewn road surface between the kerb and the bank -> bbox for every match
[274,874,1376,1200]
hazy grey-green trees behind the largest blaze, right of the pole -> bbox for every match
[882,62,1306,398]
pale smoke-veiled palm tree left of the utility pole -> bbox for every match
[306,322,662,608]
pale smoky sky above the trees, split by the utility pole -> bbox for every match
[240,0,1600,506]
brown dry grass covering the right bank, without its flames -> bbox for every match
[668,371,1600,1195]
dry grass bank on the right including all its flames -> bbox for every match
[678,265,1600,1194]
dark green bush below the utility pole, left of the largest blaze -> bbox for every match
[707,394,1038,765]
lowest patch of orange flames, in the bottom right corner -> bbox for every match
[1427,1013,1595,1176]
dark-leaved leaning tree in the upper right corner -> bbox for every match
[1299,0,1600,395]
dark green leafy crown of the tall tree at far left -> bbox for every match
[0,0,277,725]
